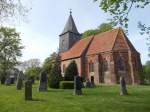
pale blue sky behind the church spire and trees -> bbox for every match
[10,0,150,64]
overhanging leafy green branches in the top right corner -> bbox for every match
[94,0,150,54]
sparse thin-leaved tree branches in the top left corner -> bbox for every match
[0,0,29,23]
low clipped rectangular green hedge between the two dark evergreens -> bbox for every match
[59,81,74,89]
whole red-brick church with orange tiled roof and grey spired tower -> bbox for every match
[59,13,142,85]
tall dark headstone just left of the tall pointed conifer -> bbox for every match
[39,71,47,91]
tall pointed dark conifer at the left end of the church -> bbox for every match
[48,56,62,88]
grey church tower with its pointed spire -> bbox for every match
[59,11,81,53]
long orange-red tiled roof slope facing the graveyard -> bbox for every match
[60,28,136,60]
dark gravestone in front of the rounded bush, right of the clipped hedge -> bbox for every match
[74,76,82,95]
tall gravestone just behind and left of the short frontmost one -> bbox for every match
[16,71,23,90]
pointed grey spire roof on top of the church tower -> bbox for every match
[61,11,79,34]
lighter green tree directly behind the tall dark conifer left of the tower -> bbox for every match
[43,52,58,73]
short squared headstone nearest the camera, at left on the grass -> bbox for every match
[25,80,32,100]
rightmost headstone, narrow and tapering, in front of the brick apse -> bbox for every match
[120,76,128,95]
